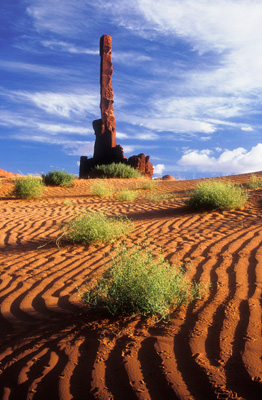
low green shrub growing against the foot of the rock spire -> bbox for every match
[93,163,142,178]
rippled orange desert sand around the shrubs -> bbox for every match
[0,173,262,400]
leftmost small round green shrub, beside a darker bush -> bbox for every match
[13,177,44,199]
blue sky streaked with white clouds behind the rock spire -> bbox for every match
[0,0,262,179]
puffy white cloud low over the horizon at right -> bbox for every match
[178,143,262,174]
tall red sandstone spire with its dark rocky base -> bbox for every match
[79,35,154,179]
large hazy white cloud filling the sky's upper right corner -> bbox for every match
[107,0,262,94]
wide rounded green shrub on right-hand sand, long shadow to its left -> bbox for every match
[187,181,248,210]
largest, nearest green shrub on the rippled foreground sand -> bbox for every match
[81,245,201,319]
